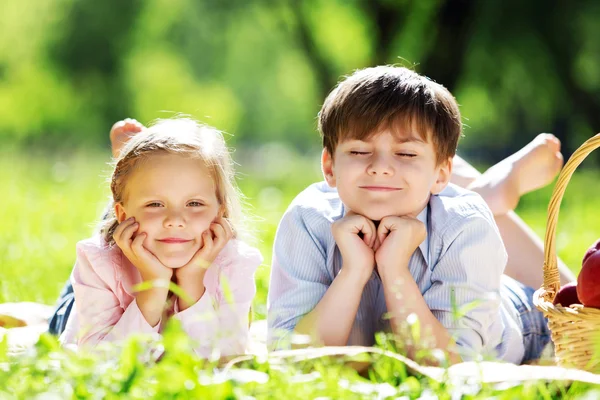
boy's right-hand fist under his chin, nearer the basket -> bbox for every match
[375,216,427,275]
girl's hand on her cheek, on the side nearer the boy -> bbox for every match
[175,217,233,286]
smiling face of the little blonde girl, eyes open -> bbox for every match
[115,153,221,268]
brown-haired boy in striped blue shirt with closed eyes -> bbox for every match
[268,66,549,363]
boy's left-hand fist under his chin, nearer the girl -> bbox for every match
[331,212,377,283]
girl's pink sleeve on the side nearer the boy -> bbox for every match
[173,244,263,358]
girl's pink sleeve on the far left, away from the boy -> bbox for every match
[71,244,160,347]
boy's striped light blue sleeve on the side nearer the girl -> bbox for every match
[267,207,333,349]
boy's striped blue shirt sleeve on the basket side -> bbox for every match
[423,214,507,360]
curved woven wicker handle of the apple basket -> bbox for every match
[544,133,600,302]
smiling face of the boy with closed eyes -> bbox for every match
[322,126,452,221]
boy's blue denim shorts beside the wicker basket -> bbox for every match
[501,276,550,363]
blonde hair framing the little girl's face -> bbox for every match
[100,118,242,245]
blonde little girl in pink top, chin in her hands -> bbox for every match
[61,119,262,357]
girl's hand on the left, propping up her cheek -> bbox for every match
[113,217,173,284]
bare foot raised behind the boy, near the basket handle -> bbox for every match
[468,133,563,215]
